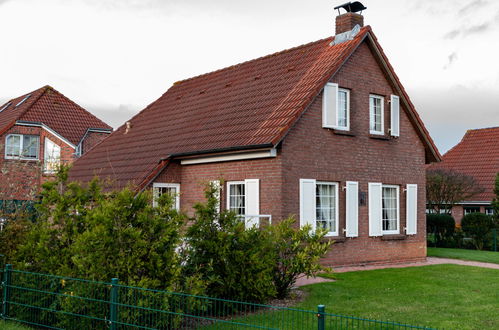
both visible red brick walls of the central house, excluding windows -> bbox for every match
[154,43,426,265]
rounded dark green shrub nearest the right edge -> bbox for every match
[461,212,496,250]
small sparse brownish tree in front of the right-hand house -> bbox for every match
[426,169,483,214]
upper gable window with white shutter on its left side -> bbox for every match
[322,83,350,131]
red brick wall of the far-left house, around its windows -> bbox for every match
[0,126,74,200]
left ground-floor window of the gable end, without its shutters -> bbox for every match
[315,184,336,232]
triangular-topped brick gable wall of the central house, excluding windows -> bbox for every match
[282,44,426,265]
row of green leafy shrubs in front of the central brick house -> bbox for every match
[0,168,330,303]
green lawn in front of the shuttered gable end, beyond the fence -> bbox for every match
[297,265,499,329]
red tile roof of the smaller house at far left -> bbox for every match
[0,86,112,145]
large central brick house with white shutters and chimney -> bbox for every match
[70,13,440,265]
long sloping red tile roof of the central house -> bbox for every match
[70,26,438,188]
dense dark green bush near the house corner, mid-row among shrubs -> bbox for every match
[184,186,276,303]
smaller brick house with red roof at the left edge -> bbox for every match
[0,86,112,202]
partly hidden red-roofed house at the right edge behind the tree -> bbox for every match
[429,127,499,225]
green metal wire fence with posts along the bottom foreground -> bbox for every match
[1,265,438,330]
